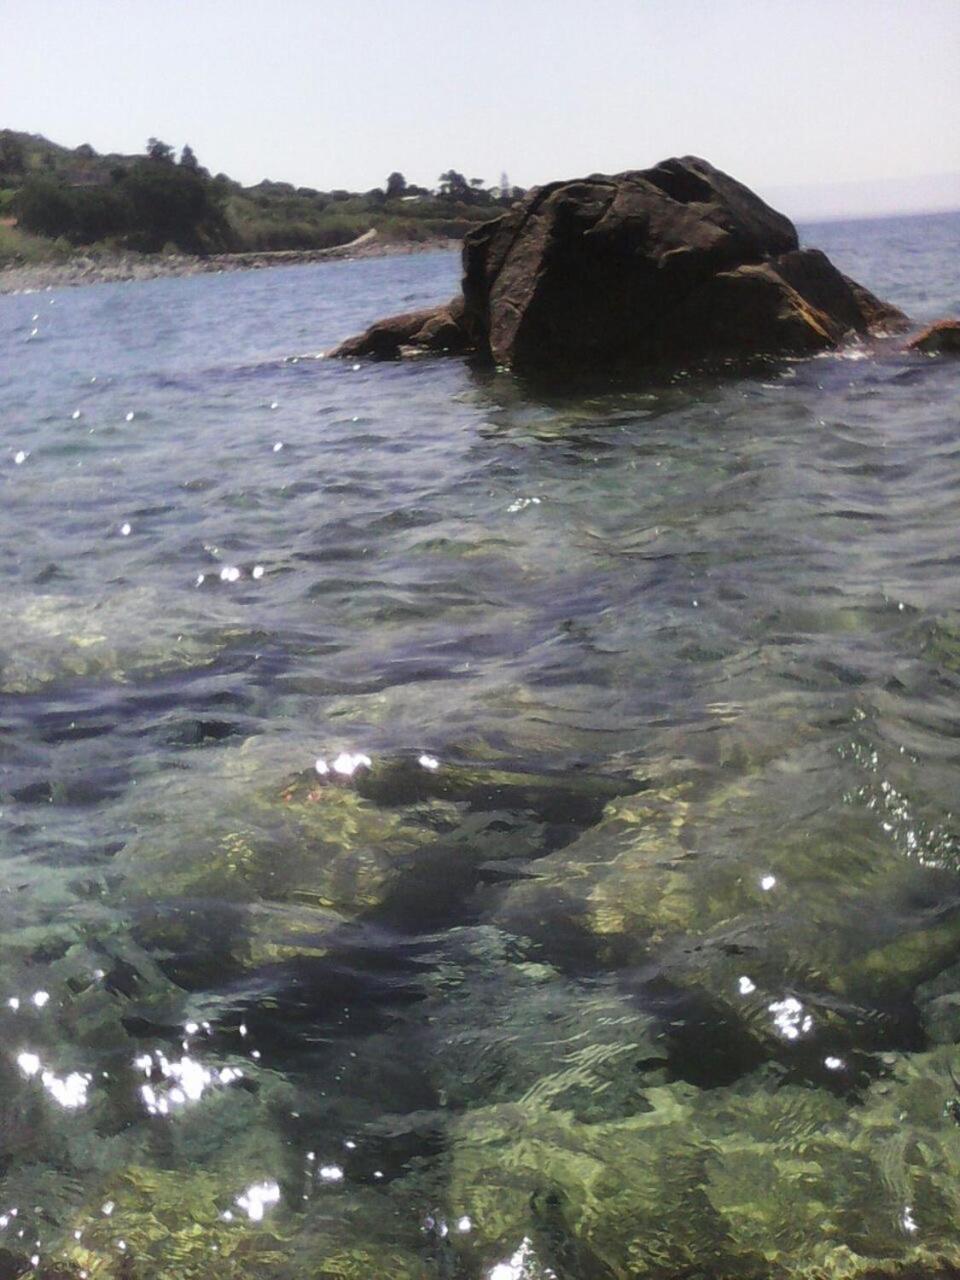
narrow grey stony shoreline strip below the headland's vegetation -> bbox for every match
[0,234,461,294]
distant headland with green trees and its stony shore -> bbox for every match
[0,129,525,292]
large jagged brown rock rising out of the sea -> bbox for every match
[333,156,904,369]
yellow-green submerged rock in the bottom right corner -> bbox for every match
[449,1051,960,1280]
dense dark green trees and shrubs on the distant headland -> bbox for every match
[0,129,522,260]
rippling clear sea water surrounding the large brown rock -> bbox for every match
[0,215,960,1280]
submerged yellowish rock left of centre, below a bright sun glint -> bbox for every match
[111,740,640,986]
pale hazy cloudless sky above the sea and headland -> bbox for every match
[0,0,960,211]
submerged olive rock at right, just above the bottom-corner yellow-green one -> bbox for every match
[485,755,960,1085]
